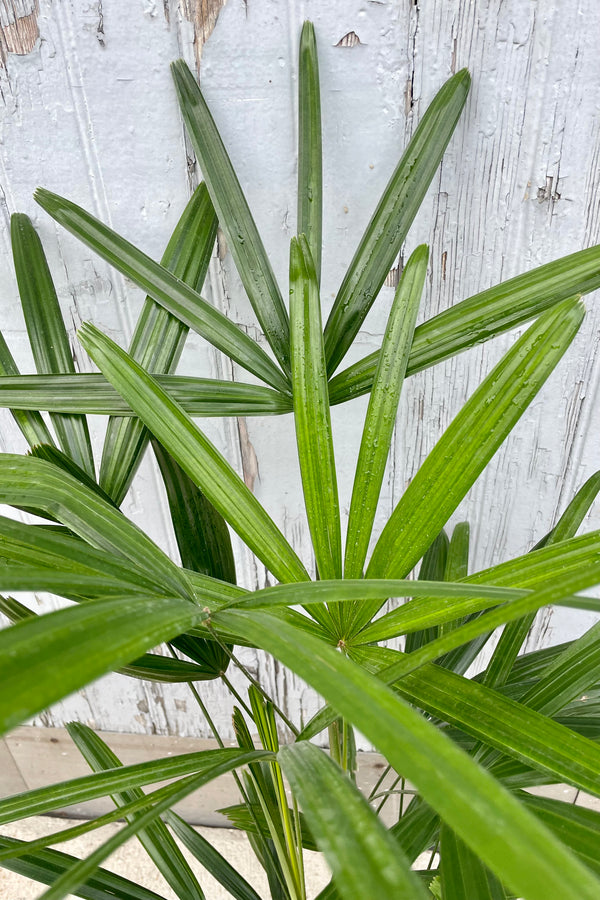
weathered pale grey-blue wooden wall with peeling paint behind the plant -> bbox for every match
[0,0,600,735]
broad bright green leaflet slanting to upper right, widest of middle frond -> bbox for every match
[367,301,583,577]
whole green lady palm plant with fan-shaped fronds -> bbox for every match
[0,23,600,900]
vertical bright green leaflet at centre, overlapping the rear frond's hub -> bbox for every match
[290,235,342,578]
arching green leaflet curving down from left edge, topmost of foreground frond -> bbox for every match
[0,453,191,596]
